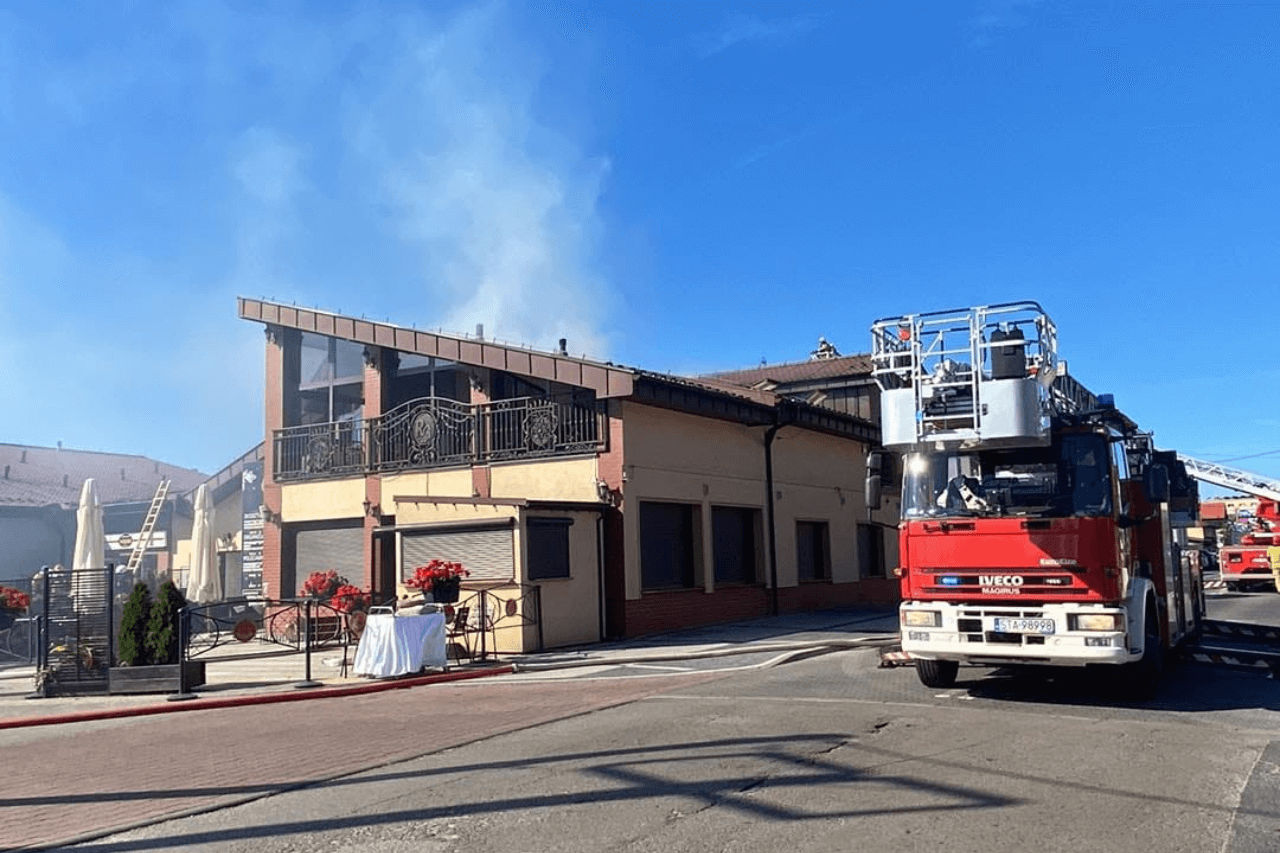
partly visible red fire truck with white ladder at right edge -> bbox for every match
[1180,456,1280,592]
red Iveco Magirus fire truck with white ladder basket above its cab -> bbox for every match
[867,302,1204,692]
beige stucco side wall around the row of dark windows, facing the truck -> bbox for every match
[623,401,897,598]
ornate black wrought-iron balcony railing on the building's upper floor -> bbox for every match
[273,392,608,482]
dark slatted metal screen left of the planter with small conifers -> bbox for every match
[36,566,115,695]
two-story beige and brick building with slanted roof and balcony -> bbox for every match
[239,298,897,651]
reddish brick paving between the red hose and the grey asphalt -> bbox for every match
[0,675,721,849]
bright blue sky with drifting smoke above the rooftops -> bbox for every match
[0,0,1280,489]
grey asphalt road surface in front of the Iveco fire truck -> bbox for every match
[62,584,1280,853]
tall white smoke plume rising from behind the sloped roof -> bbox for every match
[347,5,609,355]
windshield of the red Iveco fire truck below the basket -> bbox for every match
[902,434,1111,519]
